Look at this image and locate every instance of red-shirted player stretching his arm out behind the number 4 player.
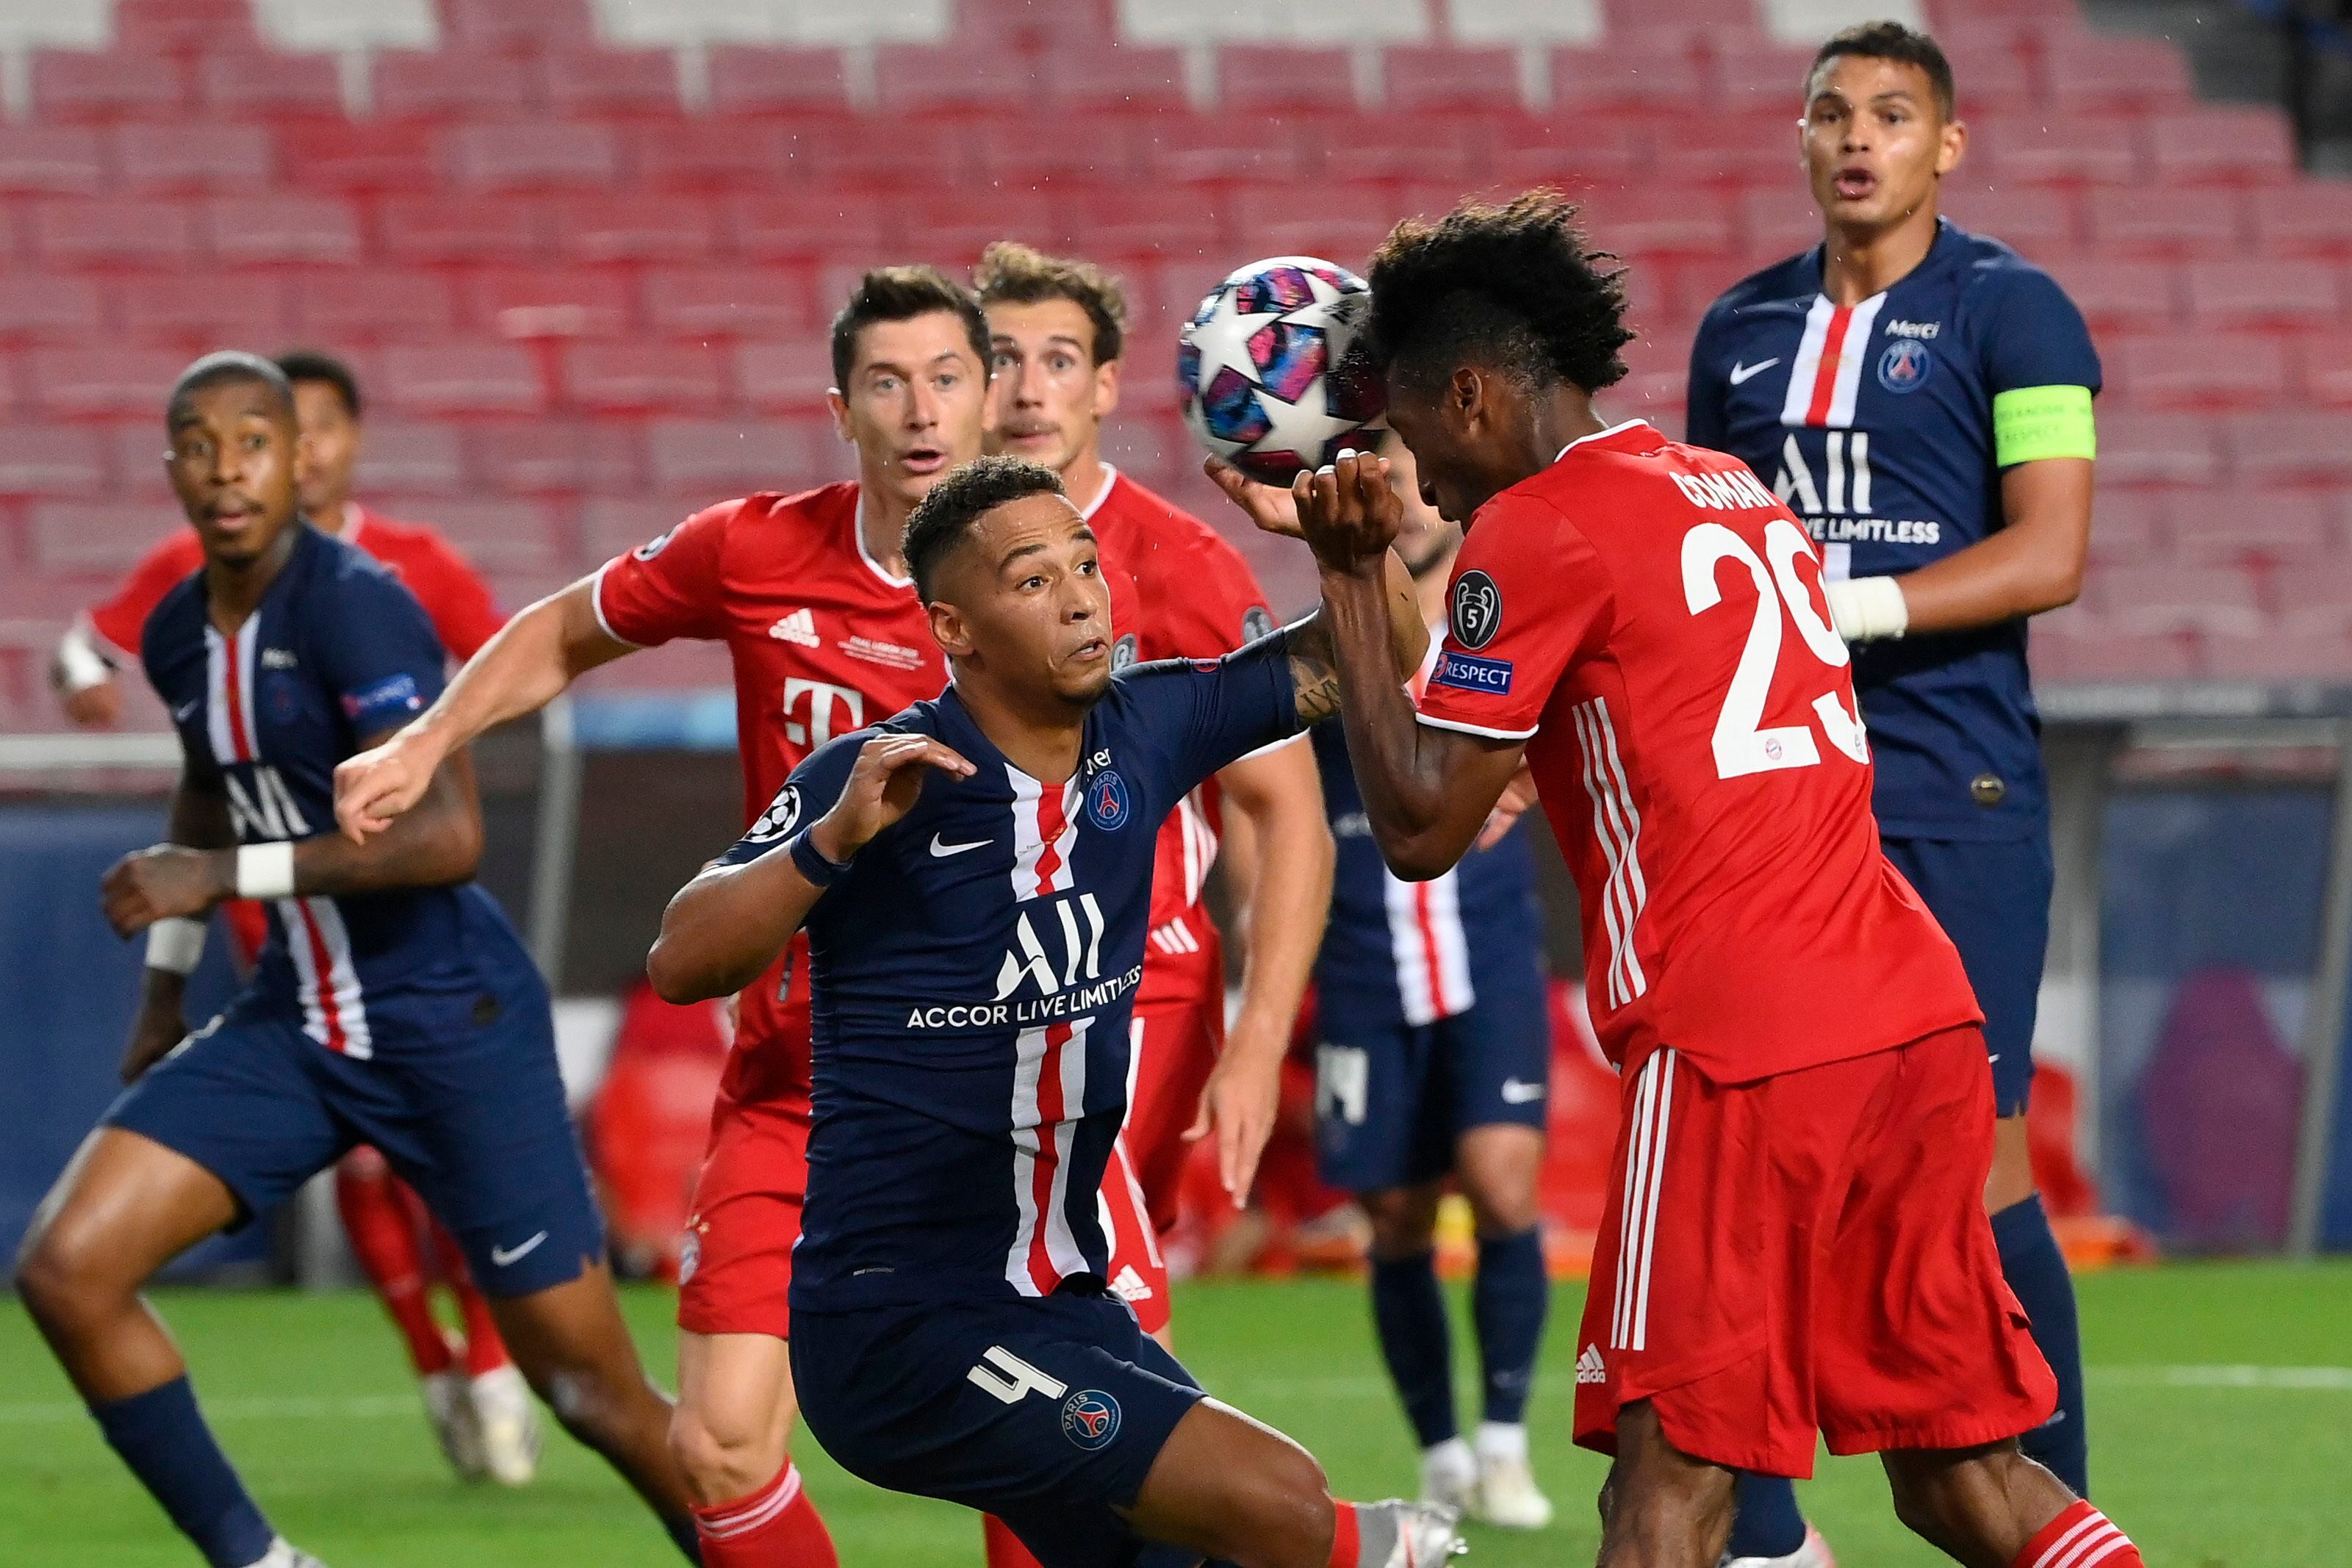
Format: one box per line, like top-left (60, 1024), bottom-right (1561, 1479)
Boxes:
top-left (337, 268), bottom-right (1195, 1568)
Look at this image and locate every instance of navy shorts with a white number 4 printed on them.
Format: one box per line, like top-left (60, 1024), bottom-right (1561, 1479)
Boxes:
top-left (793, 1290), bottom-right (1202, 1568)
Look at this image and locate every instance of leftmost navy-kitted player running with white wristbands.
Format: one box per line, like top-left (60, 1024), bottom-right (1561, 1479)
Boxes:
top-left (16, 353), bottom-right (694, 1568)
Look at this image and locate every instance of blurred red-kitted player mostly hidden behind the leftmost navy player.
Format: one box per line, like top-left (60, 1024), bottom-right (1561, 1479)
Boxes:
top-left (51, 350), bottom-right (539, 1486)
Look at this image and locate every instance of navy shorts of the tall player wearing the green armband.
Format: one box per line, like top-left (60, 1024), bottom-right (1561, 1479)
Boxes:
top-left (1884, 830), bottom-right (2053, 1117)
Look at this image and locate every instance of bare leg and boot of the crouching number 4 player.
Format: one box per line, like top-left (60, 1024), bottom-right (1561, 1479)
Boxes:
top-left (1126, 1399), bottom-right (1456, 1568)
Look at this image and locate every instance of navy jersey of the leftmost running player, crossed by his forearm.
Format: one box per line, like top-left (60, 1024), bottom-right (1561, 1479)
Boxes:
top-left (141, 524), bottom-right (529, 1056)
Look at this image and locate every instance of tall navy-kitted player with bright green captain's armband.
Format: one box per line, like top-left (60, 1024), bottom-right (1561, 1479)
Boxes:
top-left (1689, 21), bottom-right (2100, 1542)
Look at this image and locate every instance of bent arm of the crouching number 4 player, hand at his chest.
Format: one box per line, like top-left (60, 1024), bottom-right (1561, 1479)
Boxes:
top-left (644, 733), bottom-right (971, 1001)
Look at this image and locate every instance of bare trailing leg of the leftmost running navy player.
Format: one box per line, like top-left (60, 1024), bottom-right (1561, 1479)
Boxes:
top-left (477, 1262), bottom-right (694, 1558)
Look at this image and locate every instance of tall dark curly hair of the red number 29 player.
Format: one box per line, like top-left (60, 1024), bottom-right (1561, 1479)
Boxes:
top-left (1367, 190), bottom-right (1635, 392)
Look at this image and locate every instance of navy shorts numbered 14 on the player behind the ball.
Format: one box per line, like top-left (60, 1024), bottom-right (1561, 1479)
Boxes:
top-left (1315, 982), bottom-right (1553, 1192)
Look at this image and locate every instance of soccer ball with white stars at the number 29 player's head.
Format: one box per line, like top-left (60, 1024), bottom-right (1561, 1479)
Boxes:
top-left (1176, 256), bottom-right (1383, 484)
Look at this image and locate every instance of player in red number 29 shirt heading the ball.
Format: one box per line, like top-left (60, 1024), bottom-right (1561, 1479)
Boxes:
top-left (1220, 193), bottom-right (2140, 1568)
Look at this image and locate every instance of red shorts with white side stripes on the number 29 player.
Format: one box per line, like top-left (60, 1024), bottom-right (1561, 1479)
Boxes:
top-left (1576, 1025), bottom-right (2058, 1476)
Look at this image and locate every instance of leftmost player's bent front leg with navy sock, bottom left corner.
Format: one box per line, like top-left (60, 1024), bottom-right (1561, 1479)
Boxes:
top-left (16, 1129), bottom-right (311, 1568)
